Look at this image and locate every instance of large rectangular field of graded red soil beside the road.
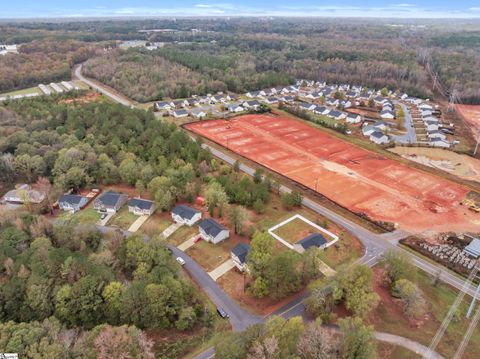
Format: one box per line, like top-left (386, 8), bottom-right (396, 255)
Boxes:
top-left (186, 115), bottom-right (480, 233)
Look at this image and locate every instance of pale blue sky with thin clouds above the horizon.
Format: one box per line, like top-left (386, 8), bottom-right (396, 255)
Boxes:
top-left (0, 0), bottom-right (480, 18)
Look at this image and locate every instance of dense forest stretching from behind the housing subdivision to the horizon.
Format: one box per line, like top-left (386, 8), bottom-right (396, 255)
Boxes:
top-left (0, 18), bottom-right (480, 103)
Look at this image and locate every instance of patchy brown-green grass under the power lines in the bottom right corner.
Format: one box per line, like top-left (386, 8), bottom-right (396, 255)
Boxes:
top-left (369, 268), bottom-right (480, 359)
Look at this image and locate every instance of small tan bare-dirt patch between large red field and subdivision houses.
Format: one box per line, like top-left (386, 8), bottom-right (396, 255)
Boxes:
top-left (389, 147), bottom-right (480, 183)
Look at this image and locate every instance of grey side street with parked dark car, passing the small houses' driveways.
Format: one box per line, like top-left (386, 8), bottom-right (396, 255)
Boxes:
top-left (168, 245), bottom-right (262, 331)
